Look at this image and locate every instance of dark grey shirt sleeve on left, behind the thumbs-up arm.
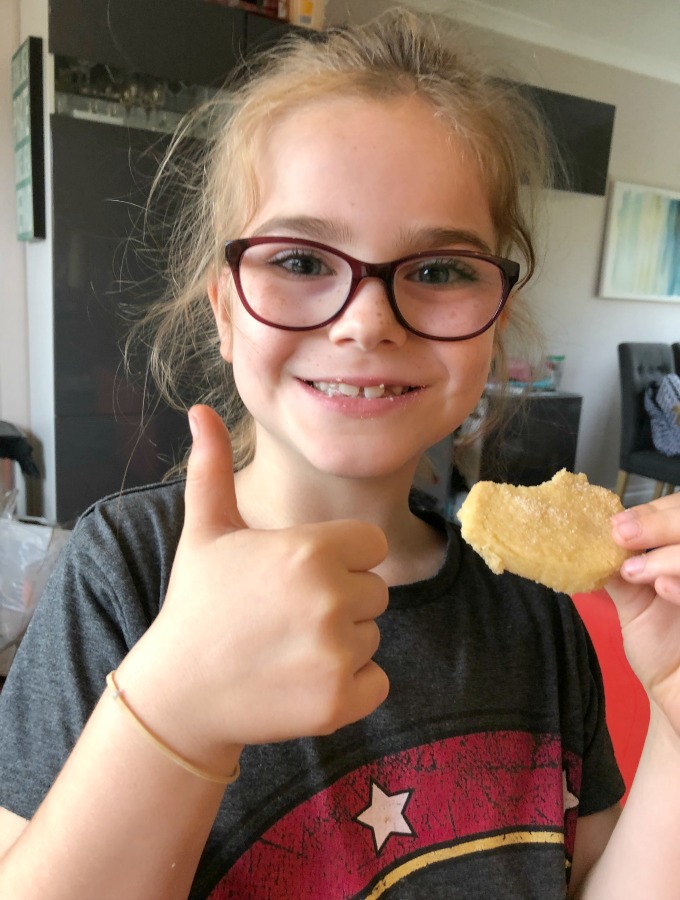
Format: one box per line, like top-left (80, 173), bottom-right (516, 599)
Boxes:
top-left (0, 502), bottom-right (155, 819)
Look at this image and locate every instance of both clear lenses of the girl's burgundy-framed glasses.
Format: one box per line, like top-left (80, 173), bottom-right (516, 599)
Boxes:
top-left (239, 241), bottom-right (503, 338)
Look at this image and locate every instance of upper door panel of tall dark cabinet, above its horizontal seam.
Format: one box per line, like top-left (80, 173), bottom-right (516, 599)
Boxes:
top-left (50, 115), bottom-right (165, 416)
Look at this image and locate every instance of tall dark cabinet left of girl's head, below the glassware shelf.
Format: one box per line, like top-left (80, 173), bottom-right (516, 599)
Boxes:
top-left (51, 115), bottom-right (188, 522)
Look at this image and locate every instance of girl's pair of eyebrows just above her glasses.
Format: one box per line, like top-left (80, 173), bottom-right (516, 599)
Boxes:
top-left (251, 216), bottom-right (495, 255)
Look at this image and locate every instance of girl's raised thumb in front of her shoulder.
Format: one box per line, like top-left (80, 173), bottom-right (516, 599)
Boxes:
top-left (184, 405), bottom-right (247, 534)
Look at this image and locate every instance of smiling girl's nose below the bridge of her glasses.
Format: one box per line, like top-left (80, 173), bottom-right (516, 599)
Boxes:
top-left (329, 276), bottom-right (407, 350)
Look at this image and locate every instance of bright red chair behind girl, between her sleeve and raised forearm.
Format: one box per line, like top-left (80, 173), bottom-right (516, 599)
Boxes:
top-left (573, 590), bottom-right (649, 802)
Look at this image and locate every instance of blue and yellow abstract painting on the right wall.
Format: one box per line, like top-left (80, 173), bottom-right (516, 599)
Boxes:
top-left (600, 181), bottom-right (680, 303)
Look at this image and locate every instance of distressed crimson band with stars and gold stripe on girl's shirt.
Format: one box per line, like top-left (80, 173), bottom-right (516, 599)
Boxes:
top-left (210, 731), bottom-right (581, 900)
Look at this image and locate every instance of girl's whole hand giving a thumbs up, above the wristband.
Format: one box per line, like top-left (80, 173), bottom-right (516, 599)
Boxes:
top-left (127, 406), bottom-right (388, 765)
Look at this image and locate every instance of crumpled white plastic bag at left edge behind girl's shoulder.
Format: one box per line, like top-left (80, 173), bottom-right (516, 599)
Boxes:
top-left (0, 517), bottom-right (70, 675)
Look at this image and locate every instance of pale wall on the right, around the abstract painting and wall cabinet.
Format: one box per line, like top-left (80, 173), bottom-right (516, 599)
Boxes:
top-left (328, 0), bottom-right (680, 501)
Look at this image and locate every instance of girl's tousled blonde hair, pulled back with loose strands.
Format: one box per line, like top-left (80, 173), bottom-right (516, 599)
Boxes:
top-left (130, 9), bottom-right (553, 467)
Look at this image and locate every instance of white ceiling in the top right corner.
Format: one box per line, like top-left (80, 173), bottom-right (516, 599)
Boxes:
top-left (448, 0), bottom-right (680, 84)
